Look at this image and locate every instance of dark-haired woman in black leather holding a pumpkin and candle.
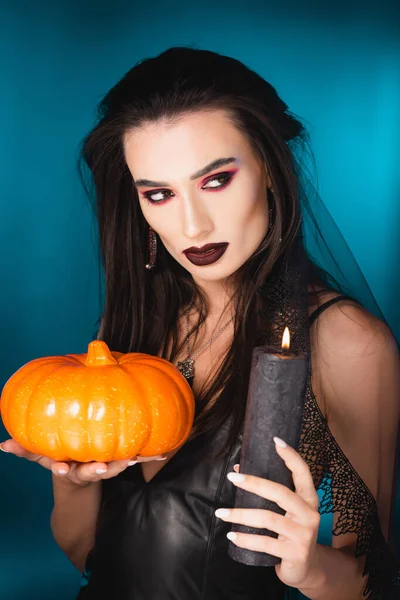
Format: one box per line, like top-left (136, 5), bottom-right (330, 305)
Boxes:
top-left (4, 48), bottom-right (400, 600)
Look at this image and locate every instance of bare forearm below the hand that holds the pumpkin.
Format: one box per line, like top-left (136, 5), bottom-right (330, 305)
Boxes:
top-left (50, 474), bottom-right (102, 572)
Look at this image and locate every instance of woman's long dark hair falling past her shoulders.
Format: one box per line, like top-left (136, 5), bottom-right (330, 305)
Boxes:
top-left (80, 47), bottom-right (329, 454)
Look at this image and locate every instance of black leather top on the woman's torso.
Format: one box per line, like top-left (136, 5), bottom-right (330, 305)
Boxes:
top-left (79, 420), bottom-right (285, 600)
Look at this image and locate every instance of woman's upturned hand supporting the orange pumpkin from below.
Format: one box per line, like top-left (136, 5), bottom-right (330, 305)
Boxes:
top-left (0, 438), bottom-right (167, 486)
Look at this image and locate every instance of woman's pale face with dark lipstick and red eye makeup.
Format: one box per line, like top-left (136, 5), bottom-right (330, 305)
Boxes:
top-left (124, 110), bottom-right (269, 285)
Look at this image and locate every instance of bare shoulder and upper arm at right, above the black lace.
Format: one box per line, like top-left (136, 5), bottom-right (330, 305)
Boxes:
top-left (311, 294), bottom-right (400, 528)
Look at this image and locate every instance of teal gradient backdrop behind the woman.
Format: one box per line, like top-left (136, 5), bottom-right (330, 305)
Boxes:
top-left (0, 0), bottom-right (400, 600)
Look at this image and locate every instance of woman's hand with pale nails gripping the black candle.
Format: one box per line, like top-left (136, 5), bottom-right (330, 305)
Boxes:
top-left (215, 438), bottom-right (320, 588)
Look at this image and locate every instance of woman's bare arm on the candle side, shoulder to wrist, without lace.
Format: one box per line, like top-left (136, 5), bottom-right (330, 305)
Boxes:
top-left (301, 302), bottom-right (400, 600)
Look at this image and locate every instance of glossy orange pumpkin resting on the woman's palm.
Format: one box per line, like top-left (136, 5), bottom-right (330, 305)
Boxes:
top-left (0, 340), bottom-right (194, 462)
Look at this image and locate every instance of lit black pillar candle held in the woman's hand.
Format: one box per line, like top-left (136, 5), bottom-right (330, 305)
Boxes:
top-left (229, 328), bottom-right (308, 567)
